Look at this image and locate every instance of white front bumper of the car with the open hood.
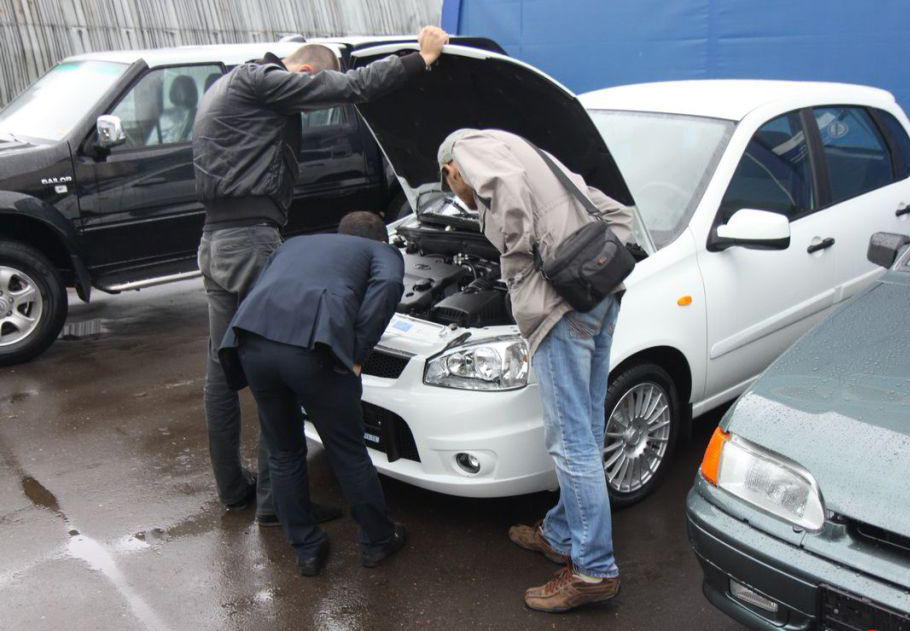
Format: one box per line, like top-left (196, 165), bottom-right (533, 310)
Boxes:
top-left (305, 366), bottom-right (558, 497)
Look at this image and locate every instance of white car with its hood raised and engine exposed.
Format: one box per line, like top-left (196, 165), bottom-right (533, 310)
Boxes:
top-left (306, 44), bottom-right (910, 504)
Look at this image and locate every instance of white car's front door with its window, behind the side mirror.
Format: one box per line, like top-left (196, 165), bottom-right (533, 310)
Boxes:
top-left (698, 111), bottom-right (837, 407)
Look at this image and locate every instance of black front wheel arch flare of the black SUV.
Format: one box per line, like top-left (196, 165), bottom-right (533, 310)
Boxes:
top-left (0, 191), bottom-right (92, 302)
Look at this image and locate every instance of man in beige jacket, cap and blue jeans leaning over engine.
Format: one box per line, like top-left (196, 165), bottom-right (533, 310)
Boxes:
top-left (438, 129), bottom-right (632, 612)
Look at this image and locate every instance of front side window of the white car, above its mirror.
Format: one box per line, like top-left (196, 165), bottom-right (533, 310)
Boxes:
top-left (719, 112), bottom-right (816, 223)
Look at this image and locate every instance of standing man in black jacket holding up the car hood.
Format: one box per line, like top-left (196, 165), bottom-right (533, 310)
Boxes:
top-left (193, 27), bottom-right (448, 525)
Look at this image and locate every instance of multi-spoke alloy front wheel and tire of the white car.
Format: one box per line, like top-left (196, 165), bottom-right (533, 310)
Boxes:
top-left (603, 363), bottom-right (682, 507)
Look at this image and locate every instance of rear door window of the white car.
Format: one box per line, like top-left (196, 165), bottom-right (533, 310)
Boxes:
top-left (813, 106), bottom-right (894, 204)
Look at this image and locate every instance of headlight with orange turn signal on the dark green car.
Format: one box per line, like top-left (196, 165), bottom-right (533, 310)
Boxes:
top-left (701, 428), bottom-right (825, 531)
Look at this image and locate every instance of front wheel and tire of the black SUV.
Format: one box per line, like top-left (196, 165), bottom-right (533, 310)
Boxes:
top-left (0, 240), bottom-right (68, 366)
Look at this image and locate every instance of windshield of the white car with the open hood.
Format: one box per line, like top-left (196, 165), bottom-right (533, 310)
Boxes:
top-left (588, 110), bottom-right (734, 248)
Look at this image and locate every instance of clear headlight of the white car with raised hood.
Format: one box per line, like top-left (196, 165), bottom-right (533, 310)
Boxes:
top-left (423, 337), bottom-right (529, 390)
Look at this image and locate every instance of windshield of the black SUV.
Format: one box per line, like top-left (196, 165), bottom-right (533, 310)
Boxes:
top-left (0, 61), bottom-right (128, 141)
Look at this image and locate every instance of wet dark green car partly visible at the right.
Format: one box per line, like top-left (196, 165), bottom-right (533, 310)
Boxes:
top-left (687, 233), bottom-right (910, 631)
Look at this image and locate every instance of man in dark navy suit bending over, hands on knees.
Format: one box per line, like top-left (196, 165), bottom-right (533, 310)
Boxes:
top-left (220, 212), bottom-right (407, 576)
